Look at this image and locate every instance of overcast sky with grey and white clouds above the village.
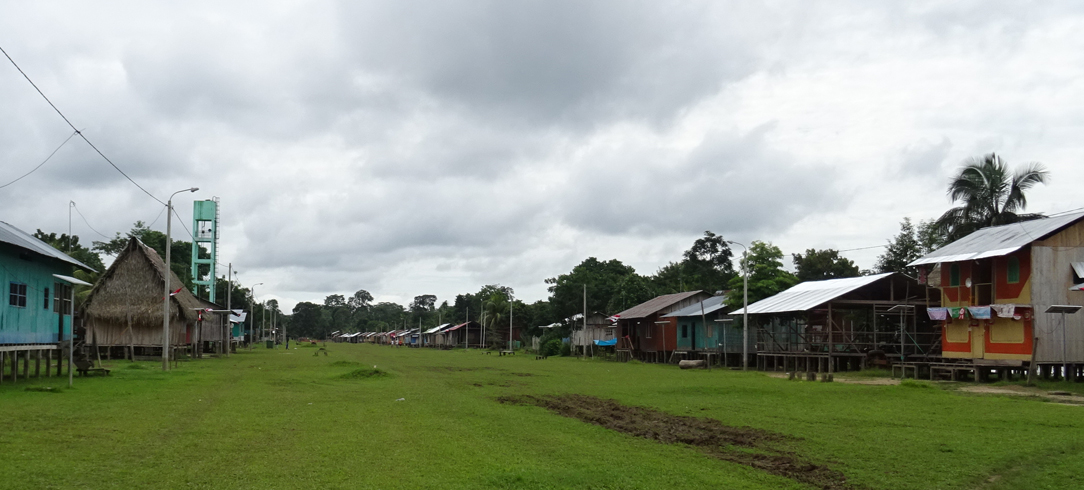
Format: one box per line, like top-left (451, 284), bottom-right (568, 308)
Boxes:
top-left (0, 0), bottom-right (1084, 308)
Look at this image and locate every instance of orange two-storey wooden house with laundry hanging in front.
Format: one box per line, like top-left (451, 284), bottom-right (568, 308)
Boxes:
top-left (911, 212), bottom-right (1084, 375)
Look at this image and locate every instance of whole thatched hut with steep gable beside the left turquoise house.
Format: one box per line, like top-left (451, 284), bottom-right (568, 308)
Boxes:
top-left (82, 237), bottom-right (204, 347)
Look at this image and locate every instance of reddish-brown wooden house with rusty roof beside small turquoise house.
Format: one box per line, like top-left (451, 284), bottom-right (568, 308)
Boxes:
top-left (615, 291), bottom-right (711, 362)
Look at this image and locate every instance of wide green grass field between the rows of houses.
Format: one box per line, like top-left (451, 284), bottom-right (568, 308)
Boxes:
top-left (0, 345), bottom-right (1084, 489)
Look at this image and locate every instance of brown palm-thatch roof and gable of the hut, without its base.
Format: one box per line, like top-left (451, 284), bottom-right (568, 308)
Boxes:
top-left (83, 237), bottom-right (203, 324)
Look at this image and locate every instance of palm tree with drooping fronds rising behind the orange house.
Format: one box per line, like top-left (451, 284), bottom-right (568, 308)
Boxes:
top-left (934, 153), bottom-right (1049, 242)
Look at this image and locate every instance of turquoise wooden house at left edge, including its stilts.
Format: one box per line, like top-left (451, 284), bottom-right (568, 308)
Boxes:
top-left (0, 221), bottom-right (93, 383)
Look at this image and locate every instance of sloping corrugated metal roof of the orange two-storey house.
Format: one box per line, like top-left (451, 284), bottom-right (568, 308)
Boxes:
top-left (908, 212), bottom-right (1084, 266)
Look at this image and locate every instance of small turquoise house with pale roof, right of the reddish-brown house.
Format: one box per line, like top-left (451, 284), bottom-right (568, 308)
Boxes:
top-left (662, 296), bottom-right (756, 365)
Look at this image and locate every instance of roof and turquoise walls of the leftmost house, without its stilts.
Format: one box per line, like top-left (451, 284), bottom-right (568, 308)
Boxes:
top-left (0, 221), bottom-right (93, 348)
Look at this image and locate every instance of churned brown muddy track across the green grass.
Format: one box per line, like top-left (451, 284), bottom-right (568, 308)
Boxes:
top-left (498, 395), bottom-right (859, 490)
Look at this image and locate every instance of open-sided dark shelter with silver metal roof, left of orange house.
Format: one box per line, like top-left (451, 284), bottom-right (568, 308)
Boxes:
top-left (731, 272), bottom-right (941, 373)
